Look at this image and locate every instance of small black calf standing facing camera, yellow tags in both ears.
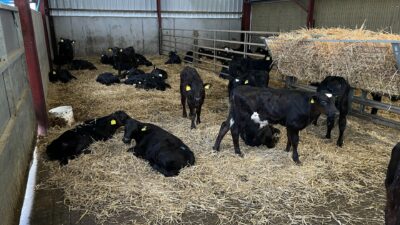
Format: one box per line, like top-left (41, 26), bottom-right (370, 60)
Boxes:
top-left (180, 66), bottom-right (211, 129)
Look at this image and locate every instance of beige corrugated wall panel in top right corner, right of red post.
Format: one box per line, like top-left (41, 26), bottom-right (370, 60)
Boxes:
top-left (314, 0), bottom-right (400, 33)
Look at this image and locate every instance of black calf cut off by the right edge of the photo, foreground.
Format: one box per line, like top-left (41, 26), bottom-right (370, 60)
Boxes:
top-left (385, 142), bottom-right (400, 225)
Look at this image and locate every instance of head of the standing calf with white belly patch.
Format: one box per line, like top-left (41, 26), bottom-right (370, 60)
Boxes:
top-left (310, 92), bottom-right (338, 118)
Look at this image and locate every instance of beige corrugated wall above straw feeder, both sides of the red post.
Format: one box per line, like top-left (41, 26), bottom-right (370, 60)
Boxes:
top-left (251, 0), bottom-right (400, 33)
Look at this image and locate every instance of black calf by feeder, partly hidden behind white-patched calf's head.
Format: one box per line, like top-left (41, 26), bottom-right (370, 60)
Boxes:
top-left (314, 76), bottom-right (350, 147)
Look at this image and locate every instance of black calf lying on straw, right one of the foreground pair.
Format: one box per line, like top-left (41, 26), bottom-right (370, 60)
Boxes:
top-left (123, 119), bottom-right (195, 177)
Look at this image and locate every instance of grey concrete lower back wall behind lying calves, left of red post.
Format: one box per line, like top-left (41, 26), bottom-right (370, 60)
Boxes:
top-left (54, 16), bottom-right (158, 57)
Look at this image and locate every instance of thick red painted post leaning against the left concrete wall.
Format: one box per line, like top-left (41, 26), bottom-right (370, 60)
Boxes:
top-left (15, 0), bottom-right (48, 136)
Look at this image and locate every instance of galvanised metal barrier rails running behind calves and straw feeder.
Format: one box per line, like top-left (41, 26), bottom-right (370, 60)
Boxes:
top-left (160, 28), bottom-right (400, 129)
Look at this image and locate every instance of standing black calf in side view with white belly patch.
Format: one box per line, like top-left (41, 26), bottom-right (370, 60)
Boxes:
top-left (213, 86), bottom-right (337, 163)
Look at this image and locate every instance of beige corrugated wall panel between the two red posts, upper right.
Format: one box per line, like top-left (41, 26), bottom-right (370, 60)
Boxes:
top-left (251, 1), bottom-right (307, 32)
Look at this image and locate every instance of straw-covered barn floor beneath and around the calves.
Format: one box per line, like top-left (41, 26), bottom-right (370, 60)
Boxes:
top-left (31, 56), bottom-right (400, 224)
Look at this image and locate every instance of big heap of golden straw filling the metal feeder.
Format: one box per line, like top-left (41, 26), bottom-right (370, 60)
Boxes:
top-left (269, 28), bottom-right (400, 95)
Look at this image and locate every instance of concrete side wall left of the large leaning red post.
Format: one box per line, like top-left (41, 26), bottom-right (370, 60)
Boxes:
top-left (0, 5), bottom-right (36, 225)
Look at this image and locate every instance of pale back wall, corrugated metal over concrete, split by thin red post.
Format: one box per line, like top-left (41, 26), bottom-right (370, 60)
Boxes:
top-left (50, 0), bottom-right (243, 56)
